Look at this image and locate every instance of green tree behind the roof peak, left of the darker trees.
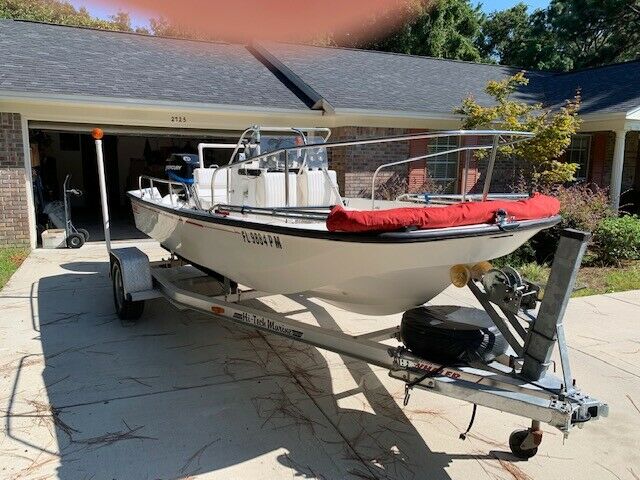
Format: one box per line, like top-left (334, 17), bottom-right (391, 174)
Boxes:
top-left (352, 0), bottom-right (482, 61)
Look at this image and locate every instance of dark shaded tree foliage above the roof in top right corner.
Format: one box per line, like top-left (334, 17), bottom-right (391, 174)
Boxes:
top-left (479, 0), bottom-right (640, 71)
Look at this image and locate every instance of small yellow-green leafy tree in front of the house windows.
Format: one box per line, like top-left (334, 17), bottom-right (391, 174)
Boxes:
top-left (455, 72), bottom-right (580, 187)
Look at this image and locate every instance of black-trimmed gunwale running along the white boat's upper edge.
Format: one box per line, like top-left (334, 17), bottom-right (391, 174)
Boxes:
top-left (127, 192), bottom-right (561, 244)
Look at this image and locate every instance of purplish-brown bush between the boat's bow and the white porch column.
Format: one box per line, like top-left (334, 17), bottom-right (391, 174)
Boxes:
top-left (531, 184), bottom-right (615, 263)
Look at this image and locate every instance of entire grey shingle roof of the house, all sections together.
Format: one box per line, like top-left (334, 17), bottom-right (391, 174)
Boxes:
top-left (0, 20), bottom-right (640, 114)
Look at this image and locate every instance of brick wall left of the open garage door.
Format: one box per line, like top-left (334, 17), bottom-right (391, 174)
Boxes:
top-left (0, 112), bottom-right (29, 246)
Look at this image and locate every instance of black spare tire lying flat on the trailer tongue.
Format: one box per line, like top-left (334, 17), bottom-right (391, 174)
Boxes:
top-left (400, 306), bottom-right (509, 364)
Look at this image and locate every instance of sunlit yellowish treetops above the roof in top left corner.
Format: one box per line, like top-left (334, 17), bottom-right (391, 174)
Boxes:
top-left (0, 0), bottom-right (138, 32)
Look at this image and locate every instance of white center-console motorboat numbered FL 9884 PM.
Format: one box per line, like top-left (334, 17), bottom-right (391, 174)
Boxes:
top-left (128, 127), bottom-right (559, 315)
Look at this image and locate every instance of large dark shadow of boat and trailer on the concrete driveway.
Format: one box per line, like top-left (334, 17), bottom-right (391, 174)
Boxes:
top-left (6, 262), bottom-right (510, 480)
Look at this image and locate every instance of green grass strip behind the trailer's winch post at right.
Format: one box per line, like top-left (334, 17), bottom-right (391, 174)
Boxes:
top-left (517, 261), bottom-right (640, 297)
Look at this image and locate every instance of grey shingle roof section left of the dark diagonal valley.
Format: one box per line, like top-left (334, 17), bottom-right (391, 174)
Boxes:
top-left (0, 20), bottom-right (308, 110)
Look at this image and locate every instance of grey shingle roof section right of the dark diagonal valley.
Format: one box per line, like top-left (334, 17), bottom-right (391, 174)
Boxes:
top-left (265, 44), bottom-right (544, 114)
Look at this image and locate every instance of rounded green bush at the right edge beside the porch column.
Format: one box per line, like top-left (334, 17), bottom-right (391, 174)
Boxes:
top-left (591, 215), bottom-right (640, 266)
